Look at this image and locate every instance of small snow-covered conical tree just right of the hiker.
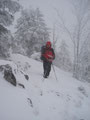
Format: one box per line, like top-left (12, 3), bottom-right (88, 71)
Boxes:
top-left (55, 40), bottom-right (72, 71)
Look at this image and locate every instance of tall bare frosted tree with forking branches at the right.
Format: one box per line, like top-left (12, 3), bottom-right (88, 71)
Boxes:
top-left (56, 0), bottom-right (90, 79)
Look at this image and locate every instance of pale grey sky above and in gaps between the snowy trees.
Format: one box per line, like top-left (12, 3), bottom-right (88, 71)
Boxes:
top-left (11, 0), bottom-right (74, 59)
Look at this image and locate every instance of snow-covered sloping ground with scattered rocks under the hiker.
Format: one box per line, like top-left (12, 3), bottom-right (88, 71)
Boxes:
top-left (0, 54), bottom-right (90, 120)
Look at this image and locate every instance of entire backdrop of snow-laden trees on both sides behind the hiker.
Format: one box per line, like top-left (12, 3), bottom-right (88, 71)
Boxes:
top-left (0, 0), bottom-right (90, 82)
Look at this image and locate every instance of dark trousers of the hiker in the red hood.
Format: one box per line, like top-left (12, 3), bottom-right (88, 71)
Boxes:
top-left (43, 61), bottom-right (52, 77)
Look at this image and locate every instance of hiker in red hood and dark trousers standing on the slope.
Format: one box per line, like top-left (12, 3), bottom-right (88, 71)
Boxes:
top-left (41, 41), bottom-right (55, 78)
